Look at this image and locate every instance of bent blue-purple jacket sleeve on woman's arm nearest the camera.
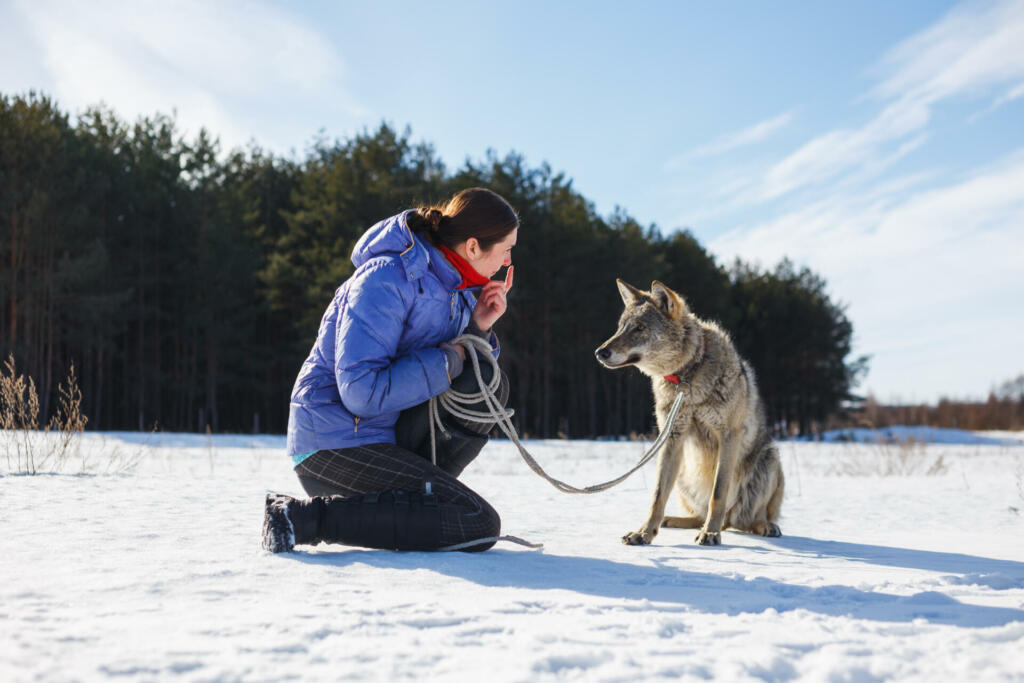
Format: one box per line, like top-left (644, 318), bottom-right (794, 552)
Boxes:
top-left (335, 263), bottom-right (452, 418)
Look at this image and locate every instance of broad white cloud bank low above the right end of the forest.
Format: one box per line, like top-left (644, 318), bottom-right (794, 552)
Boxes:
top-left (710, 145), bottom-right (1024, 399)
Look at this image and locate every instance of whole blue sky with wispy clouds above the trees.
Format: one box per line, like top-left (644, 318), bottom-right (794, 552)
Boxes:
top-left (0, 0), bottom-right (1024, 401)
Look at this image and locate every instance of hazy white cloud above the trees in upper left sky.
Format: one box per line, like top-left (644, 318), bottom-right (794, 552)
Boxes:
top-left (7, 0), bottom-right (365, 152)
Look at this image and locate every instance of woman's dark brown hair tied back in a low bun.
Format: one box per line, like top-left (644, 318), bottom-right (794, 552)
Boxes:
top-left (406, 187), bottom-right (519, 251)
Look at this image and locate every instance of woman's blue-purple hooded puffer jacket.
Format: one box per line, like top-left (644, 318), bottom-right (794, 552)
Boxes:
top-left (288, 212), bottom-right (498, 465)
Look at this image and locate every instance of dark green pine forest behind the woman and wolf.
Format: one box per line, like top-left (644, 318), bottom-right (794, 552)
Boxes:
top-left (0, 93), bottom-right (866, 437)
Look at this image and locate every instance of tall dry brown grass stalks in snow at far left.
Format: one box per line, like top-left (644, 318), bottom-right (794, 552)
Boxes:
top-left (0, 355), bottom-right (113, 474)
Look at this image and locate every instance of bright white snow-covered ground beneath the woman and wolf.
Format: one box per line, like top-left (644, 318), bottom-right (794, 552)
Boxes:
top-left (0, 434), bottom-right (1024, 683)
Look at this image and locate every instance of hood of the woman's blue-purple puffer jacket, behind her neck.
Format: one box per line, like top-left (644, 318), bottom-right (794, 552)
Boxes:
top-left (352, 211), bottom-right (462, 289)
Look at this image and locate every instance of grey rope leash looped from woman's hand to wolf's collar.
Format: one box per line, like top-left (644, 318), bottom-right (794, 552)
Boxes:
top-left (430, 334), bottom-right (690, 550)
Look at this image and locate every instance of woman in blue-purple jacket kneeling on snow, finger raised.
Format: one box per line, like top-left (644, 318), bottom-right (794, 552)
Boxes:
top-left (263, 187), bottom-right (519, 552)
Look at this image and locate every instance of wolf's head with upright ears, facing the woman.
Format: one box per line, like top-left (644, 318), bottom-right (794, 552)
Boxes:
top-left (595, 280), bottom-right (700, 377)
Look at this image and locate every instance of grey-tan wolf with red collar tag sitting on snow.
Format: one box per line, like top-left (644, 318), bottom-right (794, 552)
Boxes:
top-left (596, 280), bottom-right (784, 546)
